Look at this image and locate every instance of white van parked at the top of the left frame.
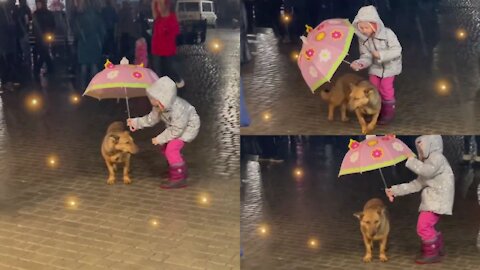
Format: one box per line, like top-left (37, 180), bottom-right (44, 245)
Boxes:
top-left (175, 0), bottom-right (217, 27)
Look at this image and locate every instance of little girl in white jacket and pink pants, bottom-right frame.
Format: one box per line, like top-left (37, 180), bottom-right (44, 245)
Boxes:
top-left (385, 135), bottom-right (455, 264)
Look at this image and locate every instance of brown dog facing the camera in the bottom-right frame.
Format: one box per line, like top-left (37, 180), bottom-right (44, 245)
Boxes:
top-left (353, 198), bottom-right (390, 262)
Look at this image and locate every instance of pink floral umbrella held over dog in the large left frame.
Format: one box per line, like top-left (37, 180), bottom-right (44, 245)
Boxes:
top-left (83, 57), bottom-right (158, 118)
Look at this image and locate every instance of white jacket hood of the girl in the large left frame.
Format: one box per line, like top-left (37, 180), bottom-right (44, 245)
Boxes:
top-left (147, 76), bottom-right (177, 110)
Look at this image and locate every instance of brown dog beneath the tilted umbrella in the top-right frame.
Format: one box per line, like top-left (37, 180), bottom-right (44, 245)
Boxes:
top-left (320, 73), bottom-right (382, 134)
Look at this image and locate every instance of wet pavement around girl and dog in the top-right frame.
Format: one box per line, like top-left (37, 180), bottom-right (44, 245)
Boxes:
top-left (241, 0), bottom-right (480, 135)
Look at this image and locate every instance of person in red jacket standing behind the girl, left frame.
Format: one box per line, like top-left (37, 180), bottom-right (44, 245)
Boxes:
top-left (152, 0), bottom-right (185, 88)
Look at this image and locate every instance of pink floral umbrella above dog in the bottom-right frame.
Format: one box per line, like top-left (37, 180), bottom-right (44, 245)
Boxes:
top-left (338, 135), bottom-right (415, 188)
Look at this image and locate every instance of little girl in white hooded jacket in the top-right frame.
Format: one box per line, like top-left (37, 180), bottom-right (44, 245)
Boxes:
top-left (351, 6), bottom-right (402, 125)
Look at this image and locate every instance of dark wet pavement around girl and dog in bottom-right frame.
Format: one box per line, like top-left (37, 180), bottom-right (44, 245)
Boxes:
top-left (241, 136), bottom-right (480, 270)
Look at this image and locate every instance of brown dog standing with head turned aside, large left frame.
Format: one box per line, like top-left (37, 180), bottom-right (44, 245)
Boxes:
top-left (102, 122), bottom-right (138, 185)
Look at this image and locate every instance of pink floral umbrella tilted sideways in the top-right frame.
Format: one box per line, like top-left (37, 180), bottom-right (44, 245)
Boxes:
top-left (297, 19), bottom-right (355, 92)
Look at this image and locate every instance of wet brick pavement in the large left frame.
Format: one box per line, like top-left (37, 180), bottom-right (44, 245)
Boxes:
top-left (0, 29), bottom-right (240, 270)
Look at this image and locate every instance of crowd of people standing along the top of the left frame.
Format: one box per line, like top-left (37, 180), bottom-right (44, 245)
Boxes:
top-left (0, 0), bottom-right (184, 91)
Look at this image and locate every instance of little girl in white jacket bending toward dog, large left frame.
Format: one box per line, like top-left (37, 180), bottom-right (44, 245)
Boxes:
top-left (127, 76), bottom-right (200, 189)
